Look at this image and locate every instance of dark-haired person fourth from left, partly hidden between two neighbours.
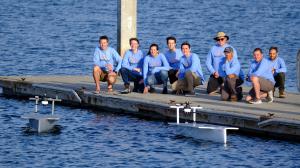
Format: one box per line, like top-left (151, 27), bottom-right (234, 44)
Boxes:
top-left (165, 36), bottom-right (183, 90)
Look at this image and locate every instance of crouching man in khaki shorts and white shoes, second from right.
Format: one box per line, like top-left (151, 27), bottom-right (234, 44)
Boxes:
top-left (246, 48), bottom-right (275, 104)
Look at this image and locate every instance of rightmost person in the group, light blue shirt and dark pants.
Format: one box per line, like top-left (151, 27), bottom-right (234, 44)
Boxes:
top-left (269, 47), bottom-right (286, 98)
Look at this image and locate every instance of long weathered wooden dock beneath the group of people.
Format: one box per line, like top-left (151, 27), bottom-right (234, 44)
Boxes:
top-left (0, 76), bottom-right (300, 140)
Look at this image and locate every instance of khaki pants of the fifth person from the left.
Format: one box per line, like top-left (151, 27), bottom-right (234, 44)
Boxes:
top-left (172, 71), bottom-right (201, 92)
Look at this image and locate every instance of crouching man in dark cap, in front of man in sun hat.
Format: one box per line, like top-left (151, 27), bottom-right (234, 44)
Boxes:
top-left (220, 47), bottom-right (244, 101)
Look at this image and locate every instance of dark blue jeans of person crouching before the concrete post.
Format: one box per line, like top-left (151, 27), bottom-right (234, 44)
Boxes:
top-left (120, 68), bottom-right (144, 92)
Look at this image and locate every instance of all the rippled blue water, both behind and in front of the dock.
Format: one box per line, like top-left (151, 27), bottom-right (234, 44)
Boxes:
top-left (0, 0), bottom-right (300, 167)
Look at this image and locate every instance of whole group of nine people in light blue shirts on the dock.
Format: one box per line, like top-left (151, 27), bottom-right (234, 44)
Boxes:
top-left (93, 32), bottom-right (286, 104)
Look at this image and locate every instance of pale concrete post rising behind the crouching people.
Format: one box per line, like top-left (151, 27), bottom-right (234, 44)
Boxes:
top-left (118, 0), bottom-right (137, 57)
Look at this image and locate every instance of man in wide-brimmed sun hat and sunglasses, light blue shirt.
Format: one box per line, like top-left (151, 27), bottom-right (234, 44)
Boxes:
top-left (206, 32), bottom-right (237, 94)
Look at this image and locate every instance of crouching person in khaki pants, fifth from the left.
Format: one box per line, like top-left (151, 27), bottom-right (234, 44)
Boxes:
top-left (176, 42), bottom-right (204, 95)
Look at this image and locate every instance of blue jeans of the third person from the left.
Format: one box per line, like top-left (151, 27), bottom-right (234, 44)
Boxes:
top-left (147, 70), bottom-right (168, 88)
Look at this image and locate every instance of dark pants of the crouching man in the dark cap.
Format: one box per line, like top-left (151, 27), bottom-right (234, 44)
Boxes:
top-left (221, 77), bottom-right (244, 100)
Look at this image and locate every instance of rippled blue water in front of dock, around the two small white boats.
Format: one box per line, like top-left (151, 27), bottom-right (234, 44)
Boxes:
top-left (0, 97), bottom-right (300, 167)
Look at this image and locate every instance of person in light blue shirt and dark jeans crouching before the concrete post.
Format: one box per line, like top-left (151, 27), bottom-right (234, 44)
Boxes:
top-left (120, 38), bottom-right (144, 93)
